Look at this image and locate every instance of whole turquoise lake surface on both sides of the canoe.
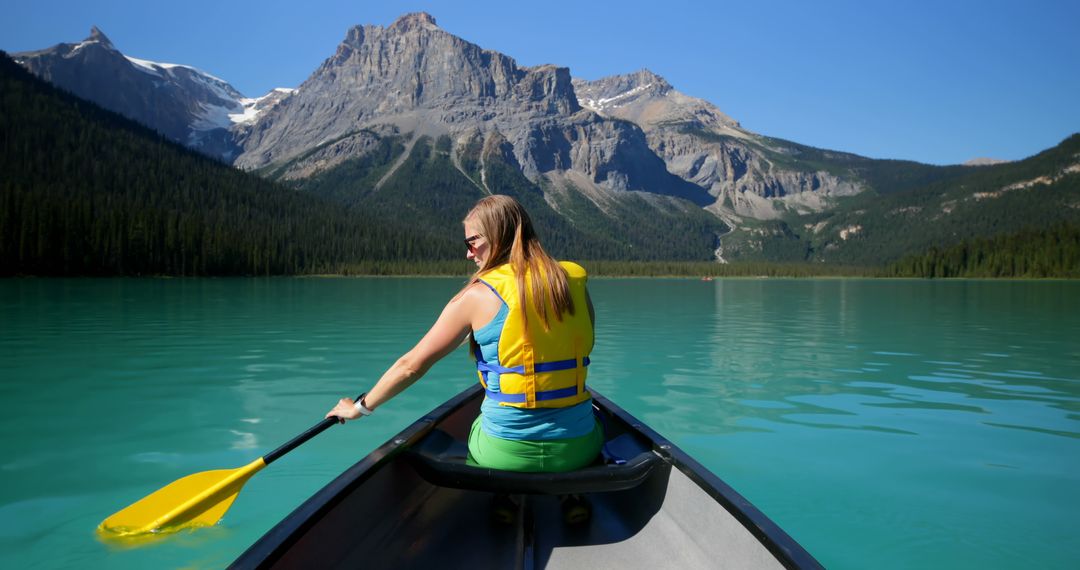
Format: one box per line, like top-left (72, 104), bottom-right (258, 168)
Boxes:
top-left (0, 279), bottom-right (1080, 569)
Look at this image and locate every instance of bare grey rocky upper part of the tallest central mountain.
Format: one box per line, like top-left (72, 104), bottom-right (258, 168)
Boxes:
top-left (237, 13), bottom-right (713, 205)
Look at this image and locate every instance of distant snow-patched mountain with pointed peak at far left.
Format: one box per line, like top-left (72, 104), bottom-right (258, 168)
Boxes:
top-left (13, 27), bottom-right (291, 162)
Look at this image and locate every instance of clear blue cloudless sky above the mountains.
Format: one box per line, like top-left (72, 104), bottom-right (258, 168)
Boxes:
top-left (0, 0), bottom-right (1080, 164)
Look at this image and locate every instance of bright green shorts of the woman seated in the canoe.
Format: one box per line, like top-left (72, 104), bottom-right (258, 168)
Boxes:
top-left (469, 417), bottom-right (604, 473)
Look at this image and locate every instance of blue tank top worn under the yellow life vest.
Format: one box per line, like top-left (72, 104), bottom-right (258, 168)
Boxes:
top-left (473, 303), bottom-right (596, 442)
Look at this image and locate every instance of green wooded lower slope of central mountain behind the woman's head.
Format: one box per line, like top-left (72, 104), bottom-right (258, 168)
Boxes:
top-left (274, 132), bottom-right (727, 261)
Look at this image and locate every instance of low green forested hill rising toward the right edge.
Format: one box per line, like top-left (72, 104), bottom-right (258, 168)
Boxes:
top-left (720, 134), bottom-right (1080, 264)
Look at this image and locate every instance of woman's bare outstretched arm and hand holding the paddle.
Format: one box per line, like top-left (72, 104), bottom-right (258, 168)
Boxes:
top-left (326, 288), bottom-right (477, 421)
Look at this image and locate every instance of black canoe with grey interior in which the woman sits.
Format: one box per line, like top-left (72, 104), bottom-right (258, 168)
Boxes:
top-left (230, 385), bottom-right (821, 569)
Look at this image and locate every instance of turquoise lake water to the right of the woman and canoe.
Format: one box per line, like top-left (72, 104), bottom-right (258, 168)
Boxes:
top-left (590, 280), bottom-right (1080, 568)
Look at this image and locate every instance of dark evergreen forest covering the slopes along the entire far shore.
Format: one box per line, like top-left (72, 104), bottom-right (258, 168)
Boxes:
top-left (0, 54), bottom-right (1080, 277)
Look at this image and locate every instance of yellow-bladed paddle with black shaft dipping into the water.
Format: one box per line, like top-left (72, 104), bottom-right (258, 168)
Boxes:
top-left (97, 396), bottom-right (360, 539)
